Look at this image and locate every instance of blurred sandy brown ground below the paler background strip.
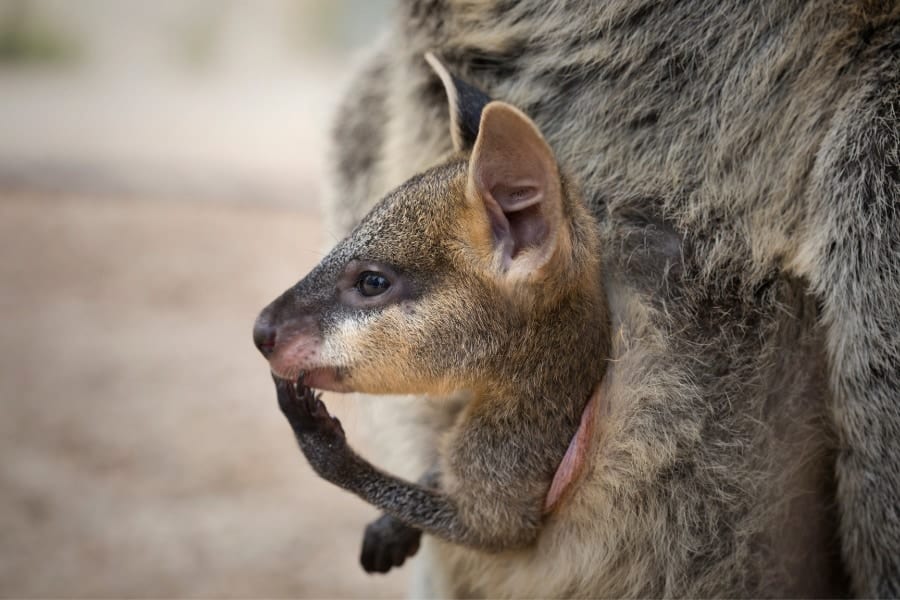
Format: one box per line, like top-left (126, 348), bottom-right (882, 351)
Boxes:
top-left (0, 192), bottom-right (409, 598)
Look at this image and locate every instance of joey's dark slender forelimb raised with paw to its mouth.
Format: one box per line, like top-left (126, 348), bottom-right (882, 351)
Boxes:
top-left (274, 375), bottom-right (521, 550)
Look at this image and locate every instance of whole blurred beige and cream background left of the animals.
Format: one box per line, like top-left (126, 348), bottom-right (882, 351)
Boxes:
top-left (0, 0), bottom-right (409, 597)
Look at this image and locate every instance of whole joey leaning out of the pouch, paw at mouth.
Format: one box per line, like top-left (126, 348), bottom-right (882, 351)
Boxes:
top-left (254, 57), bottom-right (609, 570)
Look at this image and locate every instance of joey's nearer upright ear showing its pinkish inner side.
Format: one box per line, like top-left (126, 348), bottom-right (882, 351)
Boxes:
top-left (466, 102), bottom-right (570, 278)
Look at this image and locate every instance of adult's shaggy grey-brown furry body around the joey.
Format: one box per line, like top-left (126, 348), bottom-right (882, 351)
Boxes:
top-left (320, 0), bottom-right (900, 597)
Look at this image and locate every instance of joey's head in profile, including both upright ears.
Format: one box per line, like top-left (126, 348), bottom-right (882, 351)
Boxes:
top-left (254, 57), bottom-right (599, 393)
